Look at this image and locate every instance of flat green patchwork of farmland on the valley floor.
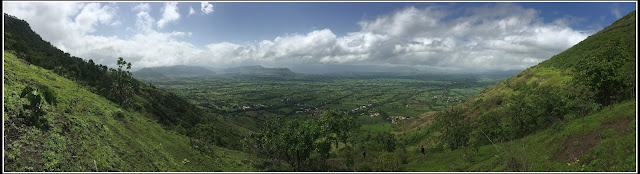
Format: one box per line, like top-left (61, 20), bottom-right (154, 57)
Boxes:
top-left (139, 74), bottom-right (502, 132)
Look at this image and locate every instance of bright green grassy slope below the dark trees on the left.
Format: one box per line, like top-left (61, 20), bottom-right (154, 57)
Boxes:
top-left (4, 52), bottom-right (254, 171)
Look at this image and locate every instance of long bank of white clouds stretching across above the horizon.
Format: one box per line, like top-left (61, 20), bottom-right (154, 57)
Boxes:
top-left (3, 2), bottom-right (589, 70)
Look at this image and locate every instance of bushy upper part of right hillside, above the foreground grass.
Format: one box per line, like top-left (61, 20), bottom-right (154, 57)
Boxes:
top-left (461, 11), bottom-right (636, 140)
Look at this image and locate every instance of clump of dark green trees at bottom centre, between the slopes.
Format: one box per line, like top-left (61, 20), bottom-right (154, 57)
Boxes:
top-left (253, 112), bottom-right (362, 170)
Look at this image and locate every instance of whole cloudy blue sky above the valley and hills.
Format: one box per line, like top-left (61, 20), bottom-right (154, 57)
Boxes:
top-left (3, 1), bottom-right (637, 71)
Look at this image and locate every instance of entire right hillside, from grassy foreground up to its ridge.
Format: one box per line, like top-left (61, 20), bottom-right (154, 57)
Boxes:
top-left (403, 11), bottom-right (637, 171)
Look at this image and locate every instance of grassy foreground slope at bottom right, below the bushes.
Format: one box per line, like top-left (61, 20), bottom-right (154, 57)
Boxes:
top-left (402, 101), bottom-right (637, 172)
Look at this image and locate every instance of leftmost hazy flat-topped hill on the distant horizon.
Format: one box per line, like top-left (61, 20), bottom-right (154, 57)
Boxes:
top-left (133, 65), bottom-right (216, 79)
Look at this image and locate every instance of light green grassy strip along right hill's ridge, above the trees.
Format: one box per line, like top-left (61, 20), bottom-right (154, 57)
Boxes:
top-left (465, 11), bottom-right (636, 117)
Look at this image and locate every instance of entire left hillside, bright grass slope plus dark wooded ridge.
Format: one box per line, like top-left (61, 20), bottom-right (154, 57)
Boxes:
top-left (4, 14), bottom-right (250, 171)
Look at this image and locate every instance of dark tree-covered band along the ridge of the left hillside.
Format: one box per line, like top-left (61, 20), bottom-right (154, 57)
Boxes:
top-left (4, 14), bottom-right (255, 150)
